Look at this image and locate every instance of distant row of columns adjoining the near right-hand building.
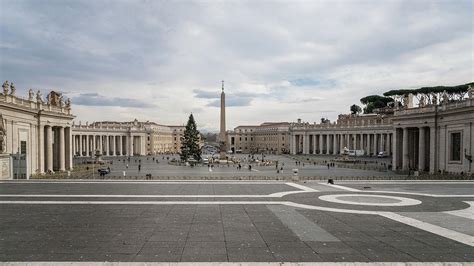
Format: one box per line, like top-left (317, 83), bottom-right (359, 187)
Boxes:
top-left (290, 132), bottom-right (392, 155)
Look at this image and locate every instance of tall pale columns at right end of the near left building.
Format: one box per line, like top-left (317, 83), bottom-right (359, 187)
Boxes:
top-left (38, 125), bottom-right (72, 173)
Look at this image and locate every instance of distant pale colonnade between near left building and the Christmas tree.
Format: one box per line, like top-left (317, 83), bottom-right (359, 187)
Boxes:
top-left (73, 133), bottom-right (146, 156)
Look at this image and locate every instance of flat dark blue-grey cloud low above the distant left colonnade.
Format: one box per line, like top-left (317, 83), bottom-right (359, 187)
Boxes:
top-left (72, 93), bottom-right (154, 108)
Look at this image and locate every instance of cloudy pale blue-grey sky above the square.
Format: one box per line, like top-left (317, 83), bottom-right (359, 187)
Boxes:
top-left (0, 0), bottom-right (474, 131)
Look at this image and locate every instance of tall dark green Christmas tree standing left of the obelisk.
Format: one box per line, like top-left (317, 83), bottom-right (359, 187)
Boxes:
top-left (180, 114), bottom-right (201, 161)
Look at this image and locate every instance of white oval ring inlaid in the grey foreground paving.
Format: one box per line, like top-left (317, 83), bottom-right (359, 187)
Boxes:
top-left (319, 194), bottom-right (421, 206)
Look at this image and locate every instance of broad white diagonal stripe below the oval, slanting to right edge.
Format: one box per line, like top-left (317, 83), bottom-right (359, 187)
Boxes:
top-left (379, 212), bottom-right (474, 247)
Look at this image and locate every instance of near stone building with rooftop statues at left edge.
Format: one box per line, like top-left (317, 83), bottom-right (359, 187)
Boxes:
top-left (0, 82), bottom-right (74, 179)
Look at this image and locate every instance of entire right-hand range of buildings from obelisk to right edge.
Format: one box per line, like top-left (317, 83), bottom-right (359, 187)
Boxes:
top-left (227, 87), bottom-right (474, 174)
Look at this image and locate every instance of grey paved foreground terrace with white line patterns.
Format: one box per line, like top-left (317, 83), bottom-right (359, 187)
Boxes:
top-left (0, 180), bottom-right (474, 264)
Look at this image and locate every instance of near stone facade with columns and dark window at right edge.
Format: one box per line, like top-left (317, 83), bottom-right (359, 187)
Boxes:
top-left (393, 94), bottom-right (474, 173)
